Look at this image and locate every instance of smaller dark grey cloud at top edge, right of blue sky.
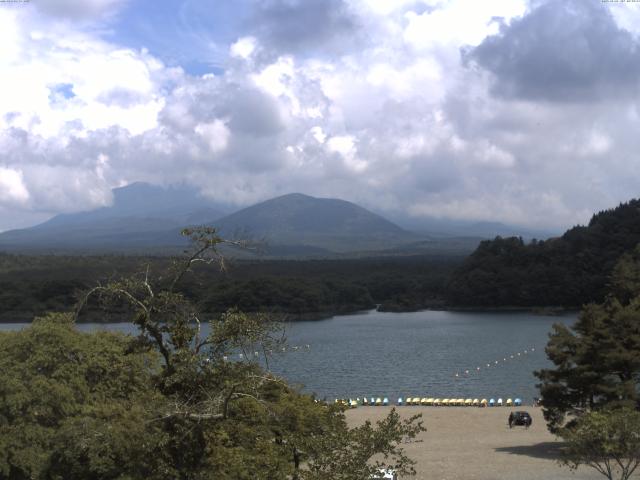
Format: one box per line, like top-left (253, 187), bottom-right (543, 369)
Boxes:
top-left (251, 0), bottom-right (358, 53)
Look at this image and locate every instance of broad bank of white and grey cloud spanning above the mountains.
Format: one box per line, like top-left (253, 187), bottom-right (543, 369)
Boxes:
top-left (0, 0), bottom-right (640, 234)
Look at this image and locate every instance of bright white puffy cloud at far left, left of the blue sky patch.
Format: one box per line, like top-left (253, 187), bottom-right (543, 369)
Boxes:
top-left (0, 11), bottom-right (172, 138)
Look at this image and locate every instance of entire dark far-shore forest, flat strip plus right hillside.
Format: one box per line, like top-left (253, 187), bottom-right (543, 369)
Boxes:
top-left (0, 195), bottom-right (640, 322)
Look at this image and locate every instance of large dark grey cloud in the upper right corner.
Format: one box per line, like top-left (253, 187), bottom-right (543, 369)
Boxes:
top-left (463, 0), bottom-right (640, 102)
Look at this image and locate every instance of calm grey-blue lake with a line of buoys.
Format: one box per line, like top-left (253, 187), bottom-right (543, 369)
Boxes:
top-left (0, 311), bottom-right (576, 403)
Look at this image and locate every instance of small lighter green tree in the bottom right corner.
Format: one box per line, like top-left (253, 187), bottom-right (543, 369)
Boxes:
top-left (561, 408), bottom-right (640, 480)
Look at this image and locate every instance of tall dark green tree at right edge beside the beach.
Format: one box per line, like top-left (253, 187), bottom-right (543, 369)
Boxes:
top-left (536, 250), bottom-right (640, 432)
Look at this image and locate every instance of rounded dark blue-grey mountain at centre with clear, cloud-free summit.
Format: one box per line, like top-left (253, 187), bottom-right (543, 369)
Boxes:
top-left (215, 193), bottom-right (421, 253)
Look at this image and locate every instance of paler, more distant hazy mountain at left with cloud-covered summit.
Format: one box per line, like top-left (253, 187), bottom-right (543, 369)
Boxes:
top-left (0, 183), bottom-right (228, 252)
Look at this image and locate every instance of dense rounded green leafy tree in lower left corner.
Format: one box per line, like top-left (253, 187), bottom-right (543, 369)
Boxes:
top-left (0, 314), bottom-right (158, 479)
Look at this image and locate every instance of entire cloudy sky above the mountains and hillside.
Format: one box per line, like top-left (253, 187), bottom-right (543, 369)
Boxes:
top-left (0, 0), bottom-right (640, 231)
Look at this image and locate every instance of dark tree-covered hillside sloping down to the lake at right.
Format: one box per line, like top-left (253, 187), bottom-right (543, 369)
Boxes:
top-left (446, 200), bottom-right (640, 307)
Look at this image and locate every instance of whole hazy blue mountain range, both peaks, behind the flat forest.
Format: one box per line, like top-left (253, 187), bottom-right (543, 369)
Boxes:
top-left (0, 183), bottom-right (479, 258)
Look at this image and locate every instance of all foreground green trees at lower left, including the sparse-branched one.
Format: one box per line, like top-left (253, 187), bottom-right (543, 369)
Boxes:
top-left (0, 230), bottom-right (424, 480)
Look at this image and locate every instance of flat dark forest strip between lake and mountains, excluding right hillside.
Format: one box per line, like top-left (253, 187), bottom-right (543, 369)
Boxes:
top-left (0, 251), bottom-right (461, 321)
